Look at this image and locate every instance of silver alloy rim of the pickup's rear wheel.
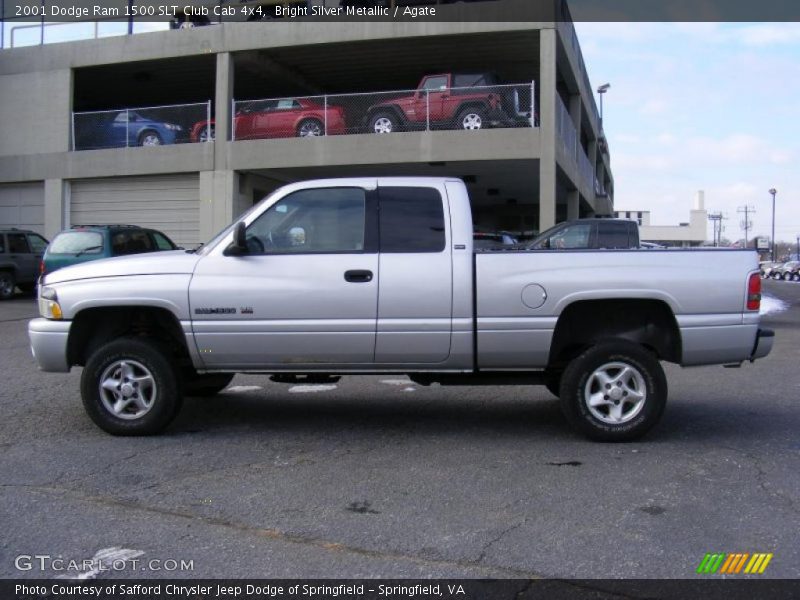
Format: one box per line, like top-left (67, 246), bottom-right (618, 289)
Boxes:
top-left (583, 362), bottom-right (647, 425)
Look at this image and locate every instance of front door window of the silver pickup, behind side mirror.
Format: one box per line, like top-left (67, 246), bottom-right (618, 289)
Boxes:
top-left (247, 188), bottom-right (367, 254)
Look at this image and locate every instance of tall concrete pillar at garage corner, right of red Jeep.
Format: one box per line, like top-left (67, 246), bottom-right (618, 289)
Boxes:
top-left (538, 29), bottom-right (557, 231)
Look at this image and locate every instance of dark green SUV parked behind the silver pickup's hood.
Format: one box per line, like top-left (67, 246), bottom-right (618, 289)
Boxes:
top-left (40, 225), bottom-right (179, 275)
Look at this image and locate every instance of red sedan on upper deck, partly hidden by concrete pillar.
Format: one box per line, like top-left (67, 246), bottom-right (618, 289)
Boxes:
top-left (190, 98), bottom-right (346, 142)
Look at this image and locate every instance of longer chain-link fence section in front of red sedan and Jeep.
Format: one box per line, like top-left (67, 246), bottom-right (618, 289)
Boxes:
top-left (223, 82), bottom-right (538, 140)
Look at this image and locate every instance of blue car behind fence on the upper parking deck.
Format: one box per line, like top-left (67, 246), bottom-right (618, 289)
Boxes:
top-left (75, 110), bottom-right (188, 150)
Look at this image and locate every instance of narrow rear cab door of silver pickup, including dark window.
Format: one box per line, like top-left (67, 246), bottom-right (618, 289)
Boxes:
top-left (375, 180), bottom-right (453, 365)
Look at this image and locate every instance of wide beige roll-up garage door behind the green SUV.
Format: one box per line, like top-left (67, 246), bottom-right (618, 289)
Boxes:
top-left (70, 173), bottom-right (200, 248)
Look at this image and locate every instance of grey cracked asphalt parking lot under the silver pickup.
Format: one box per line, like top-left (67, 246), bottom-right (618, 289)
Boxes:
top-left (0, 281), bottom-right (800, 578)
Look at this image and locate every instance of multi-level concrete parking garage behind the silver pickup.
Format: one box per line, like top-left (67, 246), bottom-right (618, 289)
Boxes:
top-left (0, 0), bottom-right (614, 246)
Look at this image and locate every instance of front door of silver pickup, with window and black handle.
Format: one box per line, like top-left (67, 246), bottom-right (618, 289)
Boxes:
top-left (189, 180), bottom-right (378, 372)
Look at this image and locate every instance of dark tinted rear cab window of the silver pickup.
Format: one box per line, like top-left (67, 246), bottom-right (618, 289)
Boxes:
top-left (378, 187), bottom-right (445, 253)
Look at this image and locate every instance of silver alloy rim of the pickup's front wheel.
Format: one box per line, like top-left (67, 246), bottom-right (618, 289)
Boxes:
top-left (100, 360), bottom-right (158, 420)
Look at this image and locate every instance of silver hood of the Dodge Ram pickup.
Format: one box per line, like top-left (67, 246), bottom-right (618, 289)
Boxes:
top-left (44, 250), bottom-right (200, 285)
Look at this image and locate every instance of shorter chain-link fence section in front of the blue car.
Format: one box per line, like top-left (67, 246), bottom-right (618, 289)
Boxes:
top-left (72, 101), bottom-right (211, 150)
